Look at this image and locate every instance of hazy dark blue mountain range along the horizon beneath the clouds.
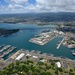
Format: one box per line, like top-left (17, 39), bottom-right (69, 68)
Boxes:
top-left (0, 12), bottom-right (75, 22)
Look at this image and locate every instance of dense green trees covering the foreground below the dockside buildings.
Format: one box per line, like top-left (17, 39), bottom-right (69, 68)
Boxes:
top-left (0, 58), bottom-right (75, 75)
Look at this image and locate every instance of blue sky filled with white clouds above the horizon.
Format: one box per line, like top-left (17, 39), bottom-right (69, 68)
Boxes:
top-left (0, 0), bottom-right (75, 14)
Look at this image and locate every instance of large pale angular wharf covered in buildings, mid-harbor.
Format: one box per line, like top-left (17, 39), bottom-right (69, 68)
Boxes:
top-left (29, 32), bottom-right (58, 45)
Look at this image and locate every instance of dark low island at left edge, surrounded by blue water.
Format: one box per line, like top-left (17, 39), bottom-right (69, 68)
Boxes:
top-left (0, 28), bottom-right (19, 36)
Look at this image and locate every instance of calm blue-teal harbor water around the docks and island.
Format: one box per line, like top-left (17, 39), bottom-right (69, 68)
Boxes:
top-left (0, 24), bottom-right (75, 59)
